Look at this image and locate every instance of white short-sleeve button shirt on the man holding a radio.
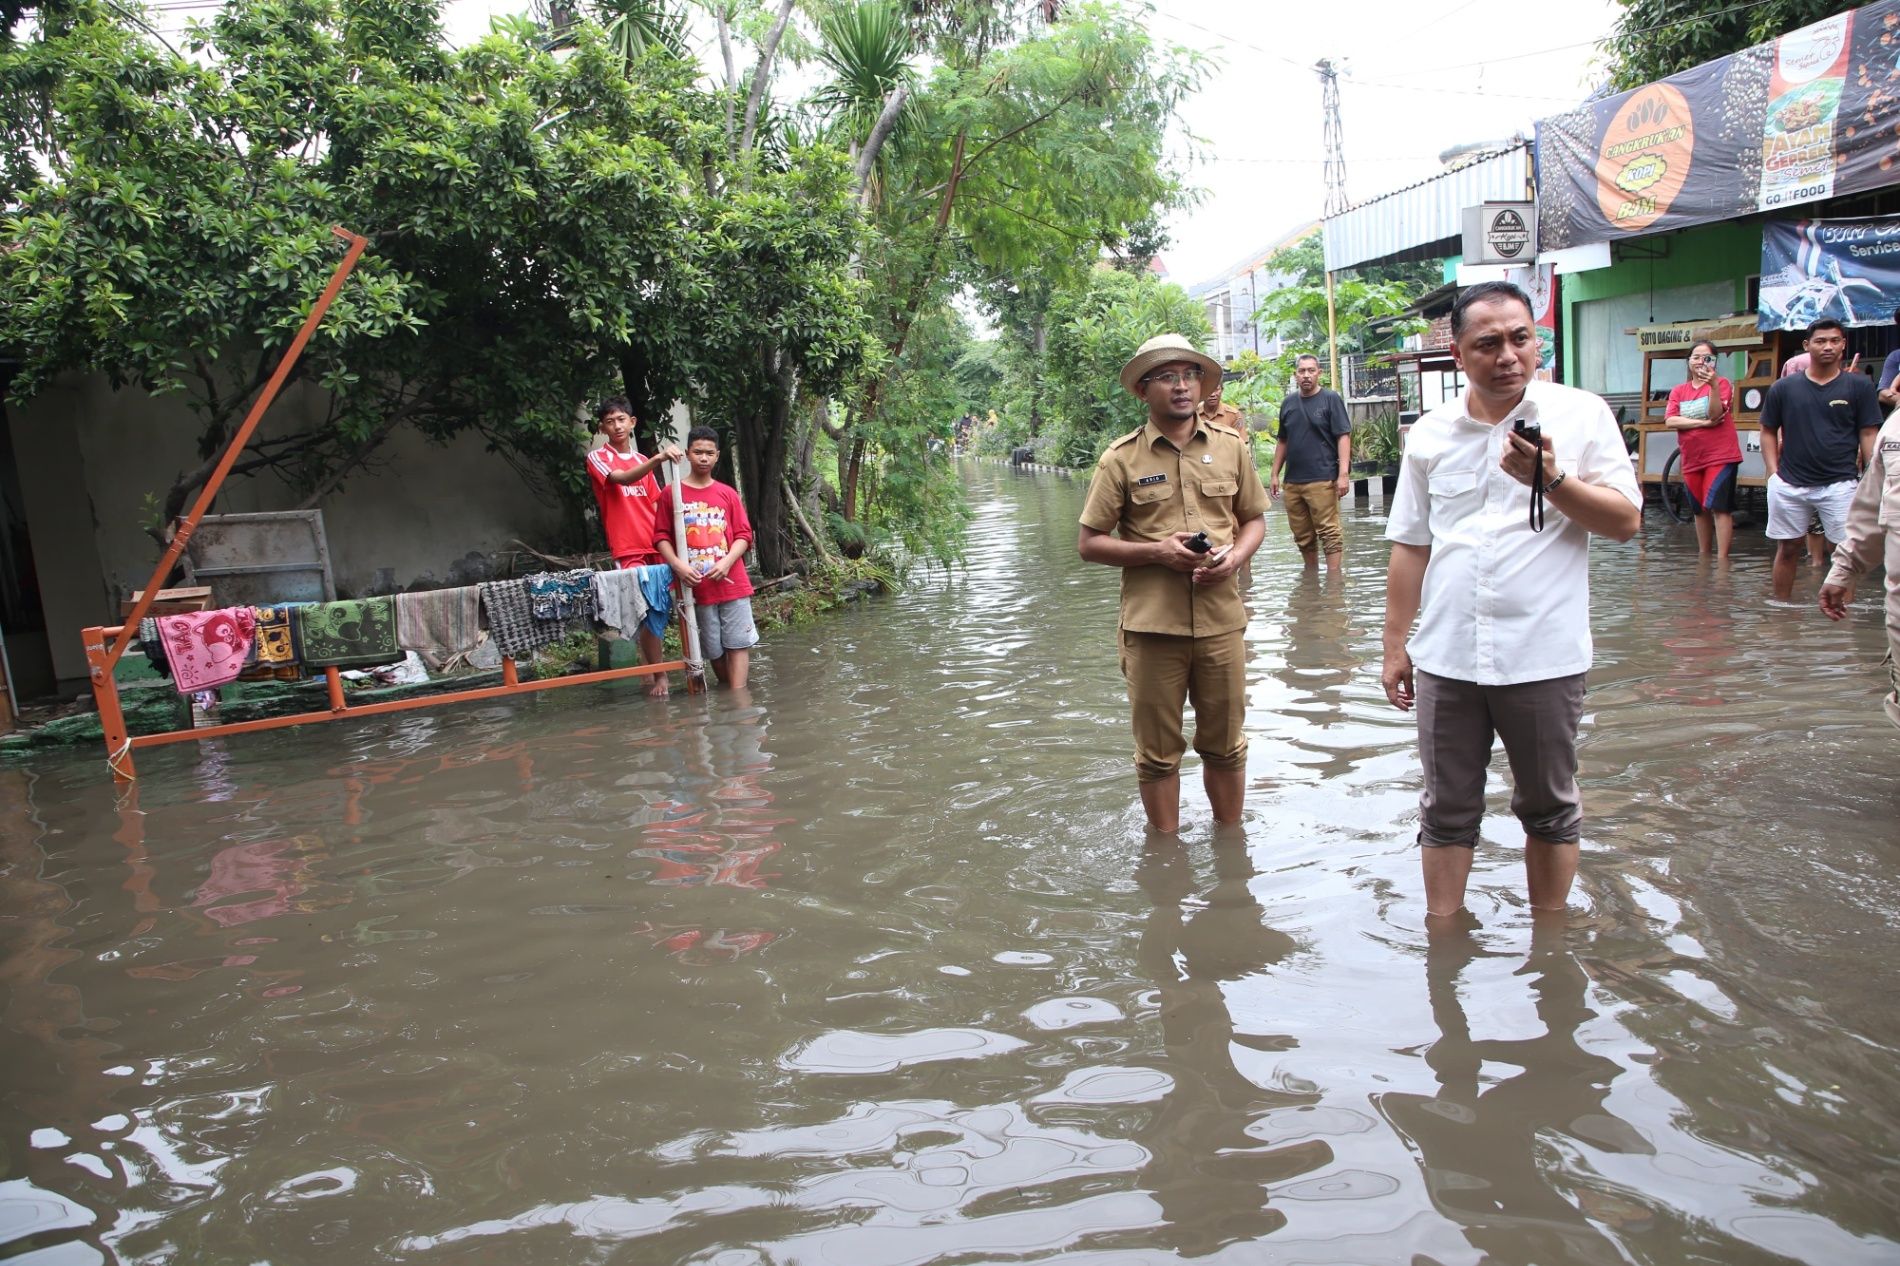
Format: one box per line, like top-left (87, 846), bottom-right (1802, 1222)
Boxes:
top-left (1385, 382), bottom-right (1644, 686)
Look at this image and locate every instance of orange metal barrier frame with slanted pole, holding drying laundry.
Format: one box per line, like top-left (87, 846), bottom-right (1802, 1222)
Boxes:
top-left (80, 228), bottom-right (705, 781)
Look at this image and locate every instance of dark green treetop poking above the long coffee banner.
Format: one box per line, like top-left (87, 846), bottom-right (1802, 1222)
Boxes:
top-left (1604, 0), bottom-right (1858, 91)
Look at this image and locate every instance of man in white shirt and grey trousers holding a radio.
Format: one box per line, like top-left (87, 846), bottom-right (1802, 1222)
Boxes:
top-left (1381, 281), bottom-right (1644, 918)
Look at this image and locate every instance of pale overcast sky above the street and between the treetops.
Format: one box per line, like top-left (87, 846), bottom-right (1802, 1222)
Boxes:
top-left (319, 0), bottom-right (1617, 285)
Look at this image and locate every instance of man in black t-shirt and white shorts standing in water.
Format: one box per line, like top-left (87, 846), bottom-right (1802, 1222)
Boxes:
top-left (1761, 317), bottom-right (1881, 601)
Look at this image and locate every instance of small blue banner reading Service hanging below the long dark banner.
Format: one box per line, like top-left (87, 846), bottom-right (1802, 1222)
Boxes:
top-left (1758, 215), bottom-right (1900, 331)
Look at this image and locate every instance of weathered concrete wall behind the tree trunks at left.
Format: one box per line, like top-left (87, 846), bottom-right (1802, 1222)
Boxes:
top-left (8, 374), bottom-right (580, 682)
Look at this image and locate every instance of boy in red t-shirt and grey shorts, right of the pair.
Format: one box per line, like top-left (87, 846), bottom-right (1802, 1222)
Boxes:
top-left (654, 426), bottom-right (758, 690)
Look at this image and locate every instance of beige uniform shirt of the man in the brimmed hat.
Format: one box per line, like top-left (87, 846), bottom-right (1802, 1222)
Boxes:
top-left (1081, 418), bottom-right (1267, 637)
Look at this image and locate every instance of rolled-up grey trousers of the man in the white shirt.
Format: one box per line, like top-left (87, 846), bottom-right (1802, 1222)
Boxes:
top-left (1416, 671), bottom-right (1583, 848)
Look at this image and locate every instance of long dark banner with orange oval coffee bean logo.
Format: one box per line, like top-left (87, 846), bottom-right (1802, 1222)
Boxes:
top-left (1537, 0), bottom-right (1900, 251)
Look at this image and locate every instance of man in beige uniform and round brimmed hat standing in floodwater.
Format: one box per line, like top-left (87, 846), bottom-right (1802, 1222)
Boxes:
top-left (1075, 335), bottom-right (1267, 833)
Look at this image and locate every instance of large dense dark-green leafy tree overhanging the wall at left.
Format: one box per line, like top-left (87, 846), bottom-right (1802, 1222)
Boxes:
top-left (0, 0), bottom-right (863, 566)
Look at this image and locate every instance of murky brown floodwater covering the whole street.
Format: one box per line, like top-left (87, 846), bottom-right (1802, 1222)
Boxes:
top-left (0, 466), bottom-right (1900, 1266)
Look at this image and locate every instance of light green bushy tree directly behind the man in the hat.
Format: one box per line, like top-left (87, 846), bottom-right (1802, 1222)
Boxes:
top-left (1045, 268), bottom-right (1212, 466)
